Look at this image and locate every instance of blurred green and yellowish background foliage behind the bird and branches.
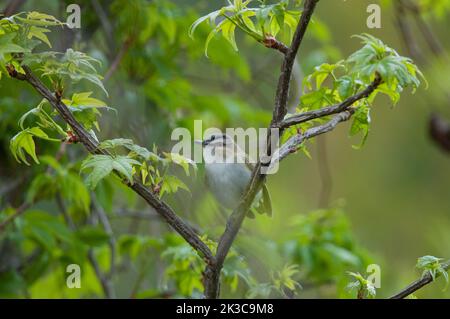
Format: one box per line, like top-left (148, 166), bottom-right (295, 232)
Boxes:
top-left (0, 0), bottom-right (450, 298)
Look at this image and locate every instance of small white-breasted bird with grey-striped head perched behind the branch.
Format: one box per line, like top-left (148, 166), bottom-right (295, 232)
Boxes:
top-left (195, 134), bottom-right (272, 218)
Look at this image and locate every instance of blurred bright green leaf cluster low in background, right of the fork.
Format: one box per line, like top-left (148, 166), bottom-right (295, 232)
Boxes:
top-left (281, 208), bottom-right (370, 292)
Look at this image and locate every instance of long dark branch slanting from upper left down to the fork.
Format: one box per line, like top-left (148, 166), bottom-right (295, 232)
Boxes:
top-left (10, 65), bottom-right (215, 264)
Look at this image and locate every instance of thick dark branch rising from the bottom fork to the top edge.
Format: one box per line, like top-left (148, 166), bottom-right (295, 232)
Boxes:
top-left (204, 0), bottom-right (319, 299)
